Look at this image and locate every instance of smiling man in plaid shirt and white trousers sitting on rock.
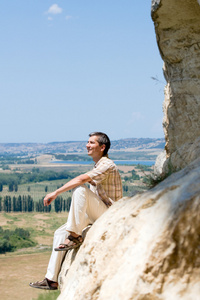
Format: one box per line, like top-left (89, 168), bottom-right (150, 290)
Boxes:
top-left (30, 132), bottom-right (122, 290)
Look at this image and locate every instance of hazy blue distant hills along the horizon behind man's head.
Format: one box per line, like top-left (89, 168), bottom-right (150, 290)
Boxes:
top-left (0, 138), bottom-right (165, 155)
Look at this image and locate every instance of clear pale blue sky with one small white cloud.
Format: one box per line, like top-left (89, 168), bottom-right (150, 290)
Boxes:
top-left (0, 0), bottom-right (165, 143)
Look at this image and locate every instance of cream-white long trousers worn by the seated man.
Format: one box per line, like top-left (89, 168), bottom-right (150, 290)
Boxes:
top-left (45, 185), bottom-right (108, 282)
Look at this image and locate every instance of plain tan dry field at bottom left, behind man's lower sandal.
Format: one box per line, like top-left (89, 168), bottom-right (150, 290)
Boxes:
top-left (0, 252), bottom-right (57, 300)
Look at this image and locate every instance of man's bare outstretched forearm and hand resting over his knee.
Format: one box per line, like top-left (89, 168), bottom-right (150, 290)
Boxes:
top-left (43, 174), bottom-right (91, 206)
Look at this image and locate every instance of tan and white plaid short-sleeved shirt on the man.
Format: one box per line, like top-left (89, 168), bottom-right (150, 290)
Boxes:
top-left (86, 156), bottom-right (123, 206)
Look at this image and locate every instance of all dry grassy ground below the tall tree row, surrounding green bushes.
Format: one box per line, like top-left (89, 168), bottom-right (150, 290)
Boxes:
top-left (0, 213), bottom-right (67, 300)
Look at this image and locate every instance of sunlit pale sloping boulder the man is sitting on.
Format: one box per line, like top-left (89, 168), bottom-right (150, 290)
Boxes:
top-left (58, 159), bottom-right (200, 300)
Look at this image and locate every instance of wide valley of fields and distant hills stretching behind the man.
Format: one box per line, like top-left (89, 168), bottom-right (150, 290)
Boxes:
top-left (0, 139), bottom-right (164, 300)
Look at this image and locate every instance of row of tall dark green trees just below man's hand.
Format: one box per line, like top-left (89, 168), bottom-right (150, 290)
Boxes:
top-left (0, 195), bottom-right (71, 213)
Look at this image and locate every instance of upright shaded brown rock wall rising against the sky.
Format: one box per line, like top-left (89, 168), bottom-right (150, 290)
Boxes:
top-left (152, 0), bottom-right (200, 172)
